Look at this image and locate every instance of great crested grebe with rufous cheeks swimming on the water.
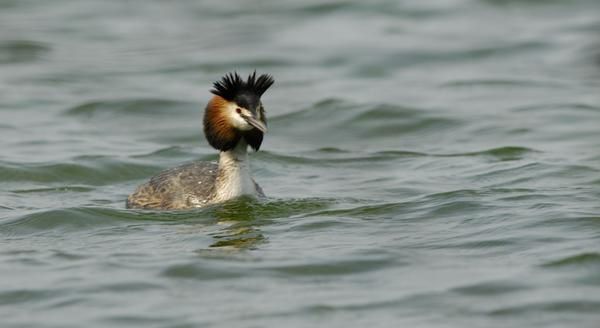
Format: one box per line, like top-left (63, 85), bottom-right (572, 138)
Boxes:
top-left (126, 71), bottom-right (275, 210)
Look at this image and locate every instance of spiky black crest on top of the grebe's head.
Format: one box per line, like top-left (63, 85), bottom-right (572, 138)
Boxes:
top-left (210, 71), bottom-right (275, 101)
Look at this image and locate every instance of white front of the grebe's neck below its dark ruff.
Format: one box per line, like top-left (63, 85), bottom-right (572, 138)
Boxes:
top-left (214, 139), bottom-right (257, 202)
